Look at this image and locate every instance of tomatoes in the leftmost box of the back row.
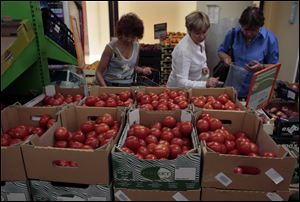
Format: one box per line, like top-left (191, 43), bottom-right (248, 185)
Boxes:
top-left (43, 93), bottom-right (83, 106)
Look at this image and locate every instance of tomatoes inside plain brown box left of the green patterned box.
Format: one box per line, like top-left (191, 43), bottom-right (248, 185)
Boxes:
top-left (54, 113), bottom-right (120, 149)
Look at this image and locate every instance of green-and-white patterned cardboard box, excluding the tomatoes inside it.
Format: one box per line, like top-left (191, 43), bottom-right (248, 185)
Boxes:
top-left (112, 109), bottom-right (201, 190)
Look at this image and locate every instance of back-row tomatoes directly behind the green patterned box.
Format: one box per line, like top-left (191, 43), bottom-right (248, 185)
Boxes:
top-left (137, 89), bottom-right (189, 111)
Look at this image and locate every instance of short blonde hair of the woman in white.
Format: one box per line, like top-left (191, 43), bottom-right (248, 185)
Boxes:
top-left (185, 11), bottom-right (210, 32)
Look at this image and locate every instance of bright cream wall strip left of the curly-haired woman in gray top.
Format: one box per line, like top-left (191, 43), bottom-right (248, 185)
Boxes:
top-left (85, 1), bottom-right (109, 64)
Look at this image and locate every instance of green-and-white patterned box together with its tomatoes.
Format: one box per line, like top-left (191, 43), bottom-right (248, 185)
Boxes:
top-left (112, 109), bottom-right (201, 190)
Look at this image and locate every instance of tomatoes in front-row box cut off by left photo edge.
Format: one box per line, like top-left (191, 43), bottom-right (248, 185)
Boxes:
top-left (1, 115), bottom-right (56, 146)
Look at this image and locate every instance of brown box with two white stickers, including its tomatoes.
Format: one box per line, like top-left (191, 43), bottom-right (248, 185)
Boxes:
top-left (195, 111), bottom-right (296, 191)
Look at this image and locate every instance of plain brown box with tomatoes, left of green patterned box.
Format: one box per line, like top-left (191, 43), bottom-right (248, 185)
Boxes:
top-left (22, 105), bottom-right (124, 185)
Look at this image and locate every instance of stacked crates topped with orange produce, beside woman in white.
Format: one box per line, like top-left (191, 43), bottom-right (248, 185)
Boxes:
top-left (160, 32), bottom-right (185, 85)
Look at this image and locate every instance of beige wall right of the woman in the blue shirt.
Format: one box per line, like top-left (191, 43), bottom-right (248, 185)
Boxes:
top-left (264, 1), bottom-right (299, 82)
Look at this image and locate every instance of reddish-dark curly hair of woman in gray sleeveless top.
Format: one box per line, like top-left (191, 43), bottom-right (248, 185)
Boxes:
top-left (117, 13), bottom-right (144, 39)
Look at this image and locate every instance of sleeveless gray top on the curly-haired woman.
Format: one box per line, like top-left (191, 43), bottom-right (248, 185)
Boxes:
top-left (103, 38), bottom-right (139, 84)
